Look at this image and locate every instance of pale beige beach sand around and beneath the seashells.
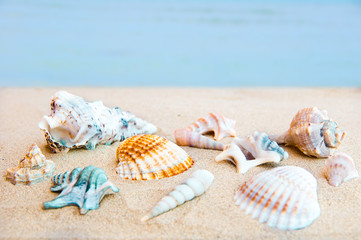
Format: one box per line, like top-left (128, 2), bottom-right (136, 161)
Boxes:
top-left (0, 88), bottom-right (361, 239)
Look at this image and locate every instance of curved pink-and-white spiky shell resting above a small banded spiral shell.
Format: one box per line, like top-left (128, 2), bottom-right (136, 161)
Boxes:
top-left (186, 113), bottom-right (236, 141)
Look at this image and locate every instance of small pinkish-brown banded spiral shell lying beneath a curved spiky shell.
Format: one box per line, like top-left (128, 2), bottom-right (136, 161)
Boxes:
top-left (174, 128), bottom-right (224, 150)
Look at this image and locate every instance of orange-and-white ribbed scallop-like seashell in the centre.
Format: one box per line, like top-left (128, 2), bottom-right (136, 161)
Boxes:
top-left (116, 134), bottom-right (193, 180)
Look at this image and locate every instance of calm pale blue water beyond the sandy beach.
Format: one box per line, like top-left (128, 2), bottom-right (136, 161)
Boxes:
top-left (0, 0), bottom-right (361, 86)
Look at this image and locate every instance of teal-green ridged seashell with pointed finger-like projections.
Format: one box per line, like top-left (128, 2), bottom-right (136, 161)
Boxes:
top-left (44, 165), bottom-right (119, 214)
